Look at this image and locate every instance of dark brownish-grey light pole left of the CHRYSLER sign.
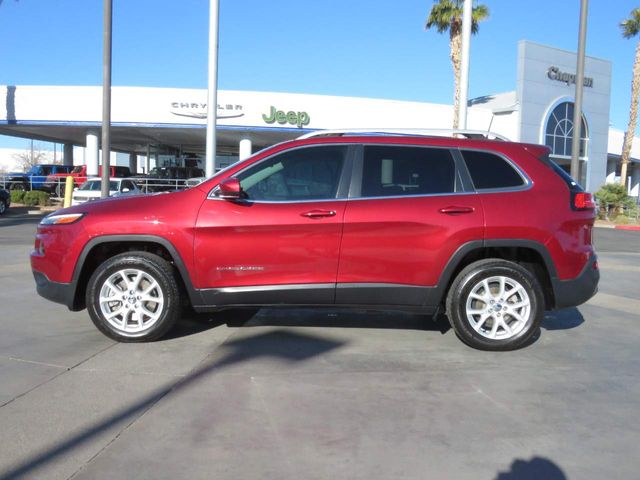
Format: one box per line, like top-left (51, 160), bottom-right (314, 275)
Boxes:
top-left (100, 0), bottom-right (113, 198)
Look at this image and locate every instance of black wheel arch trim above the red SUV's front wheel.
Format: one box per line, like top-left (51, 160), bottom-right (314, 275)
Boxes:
top-left (70, 234), bottom-right (203, 308)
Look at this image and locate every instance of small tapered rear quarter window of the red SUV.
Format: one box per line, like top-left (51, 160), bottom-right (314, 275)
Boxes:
top-left (461, 150), bottom-right (524, 190)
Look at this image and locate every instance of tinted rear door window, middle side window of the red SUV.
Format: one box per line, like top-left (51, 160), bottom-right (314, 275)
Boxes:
top-left (361, 146), bottom-right (456, 197)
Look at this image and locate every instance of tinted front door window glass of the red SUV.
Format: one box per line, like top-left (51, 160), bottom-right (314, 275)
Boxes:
top-left (236, 146), bottom-right (346, 201)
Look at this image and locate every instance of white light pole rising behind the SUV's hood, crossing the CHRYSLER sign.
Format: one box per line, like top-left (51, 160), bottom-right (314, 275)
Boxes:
top-left (205, 0), bottom-right (220, 178)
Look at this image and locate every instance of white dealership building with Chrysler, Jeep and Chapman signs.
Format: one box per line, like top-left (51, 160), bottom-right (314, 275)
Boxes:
top-left (0, 41), bottom-right (640, 197)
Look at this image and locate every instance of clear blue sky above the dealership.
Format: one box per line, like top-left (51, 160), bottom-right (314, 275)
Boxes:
top-left (0, 0), bottom-right (640, 147)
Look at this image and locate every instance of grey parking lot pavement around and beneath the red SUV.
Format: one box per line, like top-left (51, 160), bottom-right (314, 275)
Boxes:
top-left (0, 211), bottom-right (640, 480)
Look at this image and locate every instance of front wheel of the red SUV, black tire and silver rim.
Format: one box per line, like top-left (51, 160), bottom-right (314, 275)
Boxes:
top-left (86, 252), bottom-right (181, 342)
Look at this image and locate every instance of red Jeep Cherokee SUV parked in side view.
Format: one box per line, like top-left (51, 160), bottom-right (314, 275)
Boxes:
top-left (31, 134), bottom-right (599, 350)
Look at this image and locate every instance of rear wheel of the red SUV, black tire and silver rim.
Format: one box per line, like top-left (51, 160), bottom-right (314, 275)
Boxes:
top-left (446, 258), bottom-right (544, 351)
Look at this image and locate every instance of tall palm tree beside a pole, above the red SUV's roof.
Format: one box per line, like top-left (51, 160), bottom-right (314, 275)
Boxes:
top-left (425, 0), bottom-right (489, 129)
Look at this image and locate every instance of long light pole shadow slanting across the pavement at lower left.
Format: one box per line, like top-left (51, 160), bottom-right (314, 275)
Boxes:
top-left (0, 329), bottom-right (346, 480)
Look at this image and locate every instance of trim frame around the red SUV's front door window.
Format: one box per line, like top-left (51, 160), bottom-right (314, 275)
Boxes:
top-left (207, 143), bottom-right (358, 204)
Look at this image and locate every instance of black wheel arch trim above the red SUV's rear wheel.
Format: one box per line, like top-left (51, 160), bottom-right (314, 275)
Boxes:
top-left (427, 238), bottom-right (558, 305)
